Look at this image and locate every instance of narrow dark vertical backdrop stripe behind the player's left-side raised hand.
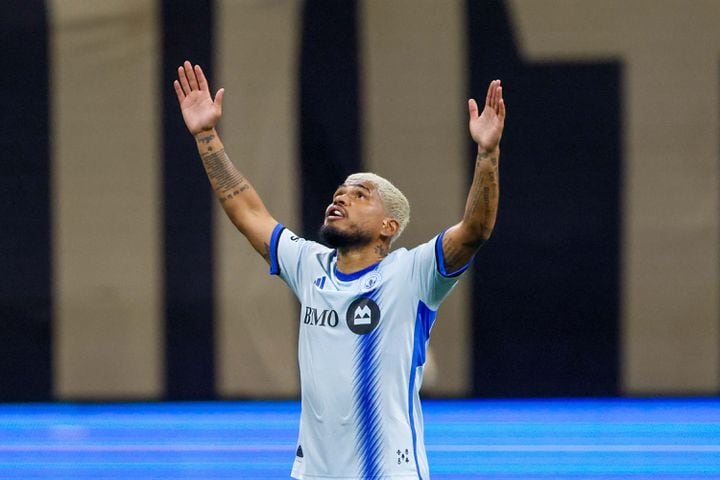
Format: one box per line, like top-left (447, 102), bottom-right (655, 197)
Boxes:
top-left (162, 0), bottom-right (215, 400)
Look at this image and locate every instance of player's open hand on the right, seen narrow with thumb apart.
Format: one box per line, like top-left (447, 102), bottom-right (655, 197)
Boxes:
top-left (468, 80), bottom-right (505, 152)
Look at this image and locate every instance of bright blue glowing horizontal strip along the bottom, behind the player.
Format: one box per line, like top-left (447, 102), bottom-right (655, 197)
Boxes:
top-left (0, 398), bottom-right (720, 480)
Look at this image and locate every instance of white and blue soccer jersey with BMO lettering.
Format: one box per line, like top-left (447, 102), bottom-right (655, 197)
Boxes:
top-left (270, 225), bottom-right (467, 480)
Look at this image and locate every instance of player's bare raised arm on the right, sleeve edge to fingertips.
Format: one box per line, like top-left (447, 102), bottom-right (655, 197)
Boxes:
top-left (442, 80), bottom-right (505, 273)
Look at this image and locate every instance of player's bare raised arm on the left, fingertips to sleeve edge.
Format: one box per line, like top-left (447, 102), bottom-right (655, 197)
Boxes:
top-left (174, 61), bottom-right (278, 262)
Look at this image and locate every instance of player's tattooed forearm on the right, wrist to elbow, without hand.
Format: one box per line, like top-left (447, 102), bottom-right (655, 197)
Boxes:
top-left (462, 148), bottom-right (500, 244)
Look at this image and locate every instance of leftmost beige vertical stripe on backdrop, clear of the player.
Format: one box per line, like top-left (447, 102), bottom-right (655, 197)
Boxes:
top-left (49, 0), bottom-right (163, 398)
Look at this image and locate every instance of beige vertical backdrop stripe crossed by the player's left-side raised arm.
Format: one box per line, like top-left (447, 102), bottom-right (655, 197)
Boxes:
top-left (214, 0), bottom-right (301, 396)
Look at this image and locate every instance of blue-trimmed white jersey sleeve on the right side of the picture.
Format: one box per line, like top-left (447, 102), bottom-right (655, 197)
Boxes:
top-left (411, 231), bottom-right (472, 310)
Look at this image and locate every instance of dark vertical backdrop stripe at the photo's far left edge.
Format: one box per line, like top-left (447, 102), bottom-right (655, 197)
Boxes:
top-left (0, 0), bottom-right (52, 401)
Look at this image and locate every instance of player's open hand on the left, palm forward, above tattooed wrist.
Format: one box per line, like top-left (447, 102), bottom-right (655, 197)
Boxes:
top-left (173, 61), bottom-right (225, 135)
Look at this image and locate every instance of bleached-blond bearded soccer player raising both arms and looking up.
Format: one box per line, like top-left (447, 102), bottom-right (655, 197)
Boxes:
top-left (174, 61), bottom-right (505, 480)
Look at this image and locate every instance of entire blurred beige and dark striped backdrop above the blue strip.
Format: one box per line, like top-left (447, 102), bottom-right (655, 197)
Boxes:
top-left (0, 0), bottom-right (720, 478)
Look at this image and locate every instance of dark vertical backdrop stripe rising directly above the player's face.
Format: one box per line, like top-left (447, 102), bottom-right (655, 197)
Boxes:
top-left (300, 0), bottom-right (362, 238)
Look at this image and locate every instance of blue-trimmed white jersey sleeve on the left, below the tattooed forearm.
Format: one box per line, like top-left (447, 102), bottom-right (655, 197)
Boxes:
top-left (270, 223), bottom-right (326, 295)
